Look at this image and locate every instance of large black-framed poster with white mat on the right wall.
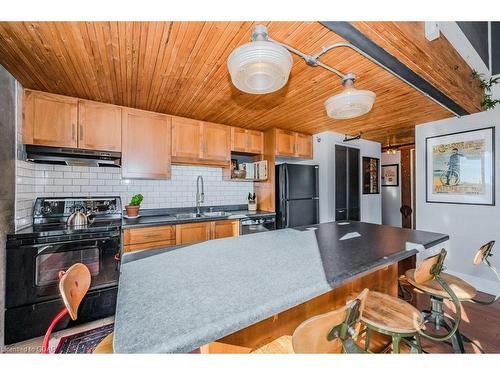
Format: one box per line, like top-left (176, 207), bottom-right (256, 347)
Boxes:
top-left (425, 127), bottom-right (495, 206)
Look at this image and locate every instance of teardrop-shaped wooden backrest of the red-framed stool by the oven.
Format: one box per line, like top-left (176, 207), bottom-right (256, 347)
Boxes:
top-left (59, 263), bottom-right (91, 320)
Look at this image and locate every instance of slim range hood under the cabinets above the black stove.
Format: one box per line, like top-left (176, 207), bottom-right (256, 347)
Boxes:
top-left (26, 145), bottom-right (121, 168)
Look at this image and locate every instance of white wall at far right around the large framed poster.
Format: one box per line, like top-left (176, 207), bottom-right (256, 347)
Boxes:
top-left (416, 108), bottom-right (500, 293)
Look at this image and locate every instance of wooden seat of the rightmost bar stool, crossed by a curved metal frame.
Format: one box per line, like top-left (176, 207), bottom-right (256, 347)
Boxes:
top-left (405, 269), bottom-right (477, 301)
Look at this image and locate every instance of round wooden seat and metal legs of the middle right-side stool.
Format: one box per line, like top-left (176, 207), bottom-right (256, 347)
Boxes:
top-left (361, 291), bottom-right (424, 354)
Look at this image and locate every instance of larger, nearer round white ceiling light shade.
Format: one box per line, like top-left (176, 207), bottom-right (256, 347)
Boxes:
top-left (227, 40), bottom-right (293, 94)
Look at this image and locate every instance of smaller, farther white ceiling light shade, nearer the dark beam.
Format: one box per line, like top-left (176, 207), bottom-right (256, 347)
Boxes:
top-left (325, 80), bottom-right (376, 120)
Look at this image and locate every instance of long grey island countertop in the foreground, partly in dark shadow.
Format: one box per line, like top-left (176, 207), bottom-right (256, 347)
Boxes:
top-left (114, 222), bottom-right (448, 353)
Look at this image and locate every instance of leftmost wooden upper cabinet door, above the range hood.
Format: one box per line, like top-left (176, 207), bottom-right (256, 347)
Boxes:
top-left (23, 90), bottom-right (78, 148)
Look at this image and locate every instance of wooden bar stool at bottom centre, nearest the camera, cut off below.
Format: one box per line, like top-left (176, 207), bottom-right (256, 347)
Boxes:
top-left (253, 289), bottom-right (368, 354)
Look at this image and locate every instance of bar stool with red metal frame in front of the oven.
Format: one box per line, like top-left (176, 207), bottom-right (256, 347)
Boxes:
top-left (42, 263), bottom-right (112, 354)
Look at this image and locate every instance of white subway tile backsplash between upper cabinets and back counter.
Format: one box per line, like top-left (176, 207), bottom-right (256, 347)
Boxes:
top-left (16, 160), bottom-right (253, 228)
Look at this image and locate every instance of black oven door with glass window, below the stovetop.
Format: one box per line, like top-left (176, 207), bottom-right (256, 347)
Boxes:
top-left (5, 236), bottom-right (120, 308)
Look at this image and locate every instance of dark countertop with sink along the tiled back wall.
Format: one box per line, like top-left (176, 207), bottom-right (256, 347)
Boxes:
top-left (122, 205), bottom-right (276, 229)
